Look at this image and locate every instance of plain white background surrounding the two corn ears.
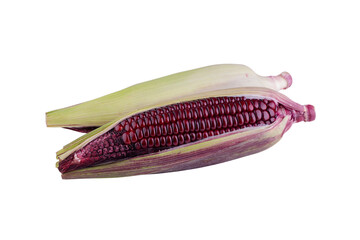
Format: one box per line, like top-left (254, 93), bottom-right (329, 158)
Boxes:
top-left (0, 0), bottom-right (360, 240)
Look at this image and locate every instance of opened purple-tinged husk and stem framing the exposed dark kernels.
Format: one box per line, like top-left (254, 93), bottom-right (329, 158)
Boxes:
top-left (57, 87), bottom-right (315, 179)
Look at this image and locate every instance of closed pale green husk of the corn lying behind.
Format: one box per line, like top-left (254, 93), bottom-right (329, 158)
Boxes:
top-left (46, 64), bottom-right (291, 127)
